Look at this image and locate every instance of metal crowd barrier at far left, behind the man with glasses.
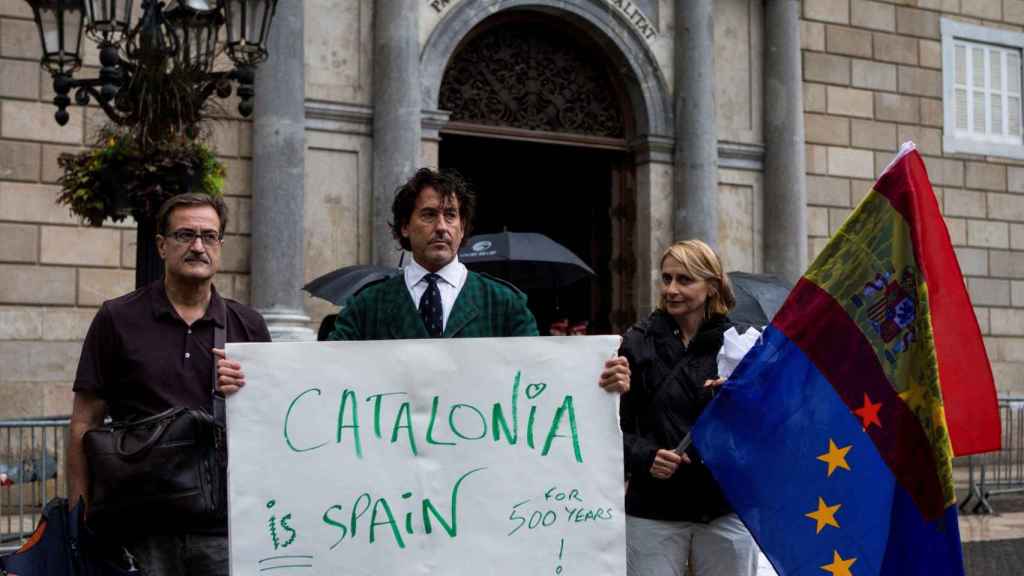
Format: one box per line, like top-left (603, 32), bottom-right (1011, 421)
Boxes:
top-left (0, 416), bottom-right (69, 550)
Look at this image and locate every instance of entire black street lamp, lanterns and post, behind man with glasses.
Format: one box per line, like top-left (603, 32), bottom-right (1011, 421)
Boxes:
top-left (26, 0), bottom-right (280, 286)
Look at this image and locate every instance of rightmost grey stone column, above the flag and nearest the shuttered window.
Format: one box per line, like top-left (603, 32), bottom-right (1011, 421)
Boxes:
top-left (762, 0), bottom-right (807, 282)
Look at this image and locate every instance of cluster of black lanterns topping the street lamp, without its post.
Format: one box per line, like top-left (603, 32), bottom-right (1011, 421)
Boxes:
top-left (26, 0), bottom-right (278, 129)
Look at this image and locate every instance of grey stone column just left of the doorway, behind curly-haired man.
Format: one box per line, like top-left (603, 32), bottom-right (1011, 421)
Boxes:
top-left (371, 0), bottom-right (423, 265)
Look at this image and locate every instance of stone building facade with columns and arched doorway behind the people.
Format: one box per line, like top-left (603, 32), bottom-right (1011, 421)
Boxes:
top-left (0, 0), bottom-right (1024, 418)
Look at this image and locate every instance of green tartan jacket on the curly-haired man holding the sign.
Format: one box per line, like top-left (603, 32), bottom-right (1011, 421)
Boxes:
top-left (328, 271), bottom-right (538, 340)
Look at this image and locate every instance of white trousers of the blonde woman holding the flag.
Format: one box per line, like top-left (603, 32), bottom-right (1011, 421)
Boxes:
top-left (626, 513), bottom-right (759, 576)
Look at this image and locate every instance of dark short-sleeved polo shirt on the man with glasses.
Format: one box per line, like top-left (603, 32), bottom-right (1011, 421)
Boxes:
top-left (74, 280), bottom-right (270, 420)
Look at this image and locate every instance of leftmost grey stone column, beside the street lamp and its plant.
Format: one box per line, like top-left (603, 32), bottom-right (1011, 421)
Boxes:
top-left (251, 2), bottom-right (315, 340)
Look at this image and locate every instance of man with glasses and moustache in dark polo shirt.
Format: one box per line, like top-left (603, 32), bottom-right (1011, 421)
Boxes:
top-left (68, 194), bottom-right (270, 576)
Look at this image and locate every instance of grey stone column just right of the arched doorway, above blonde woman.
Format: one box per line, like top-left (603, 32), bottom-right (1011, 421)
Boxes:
top-left (674, 0), bottom-right (718, 247)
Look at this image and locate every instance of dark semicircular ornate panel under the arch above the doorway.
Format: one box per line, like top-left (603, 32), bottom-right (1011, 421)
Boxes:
top-left (437, 16), bottom-right (633, 141)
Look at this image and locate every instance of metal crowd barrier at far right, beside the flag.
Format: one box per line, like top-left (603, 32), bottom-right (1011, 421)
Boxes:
top-left (959, 398), bottom-right (1024, 513)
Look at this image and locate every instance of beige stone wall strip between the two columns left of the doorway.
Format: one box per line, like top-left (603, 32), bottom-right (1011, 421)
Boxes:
top-left (304, 0), bottom-right (374, 330)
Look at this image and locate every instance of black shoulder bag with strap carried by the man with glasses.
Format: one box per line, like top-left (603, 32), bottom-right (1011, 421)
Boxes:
top-left (84, 318), bottom-right (227, 532)
